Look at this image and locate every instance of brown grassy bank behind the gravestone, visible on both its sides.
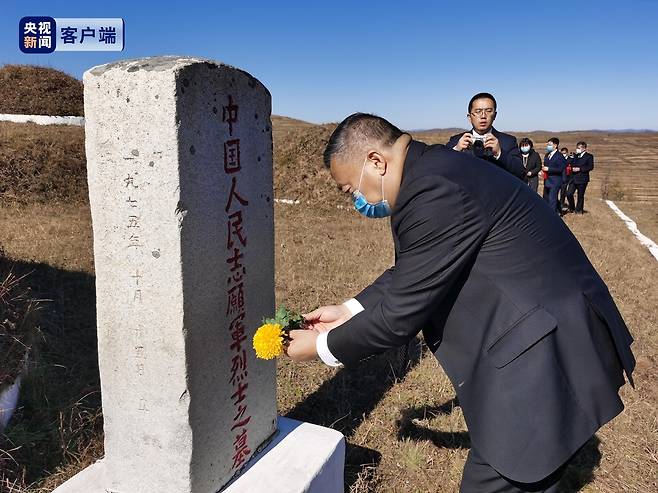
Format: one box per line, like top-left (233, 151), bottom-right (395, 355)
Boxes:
top-left (0, 116), bottom-right (345, 205)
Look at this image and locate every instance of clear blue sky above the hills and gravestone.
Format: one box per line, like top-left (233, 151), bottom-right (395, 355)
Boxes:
top-left (0, 0), bottom-right (658, 131)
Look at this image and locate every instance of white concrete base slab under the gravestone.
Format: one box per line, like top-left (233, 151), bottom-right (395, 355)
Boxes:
top-left (53, 417), bottom-right (345, 493)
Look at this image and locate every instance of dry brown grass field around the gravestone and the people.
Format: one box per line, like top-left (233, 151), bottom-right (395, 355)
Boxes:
top-left (0, 118), bottom-right (658, 493)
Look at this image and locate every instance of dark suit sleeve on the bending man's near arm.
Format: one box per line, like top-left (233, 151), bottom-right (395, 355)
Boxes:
top-left (327, 177), bottom-right (489, 365)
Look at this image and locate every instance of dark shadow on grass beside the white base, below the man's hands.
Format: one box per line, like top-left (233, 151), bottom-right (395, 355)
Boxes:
top-left (286, 339), bottom-right (422, 491)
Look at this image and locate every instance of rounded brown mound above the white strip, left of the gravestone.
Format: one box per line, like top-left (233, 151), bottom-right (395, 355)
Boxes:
top-left (0, 65), bottom-right (84, 116)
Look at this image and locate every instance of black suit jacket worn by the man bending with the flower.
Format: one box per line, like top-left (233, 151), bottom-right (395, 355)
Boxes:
top-left (327, 141), bottom-right (635, 482)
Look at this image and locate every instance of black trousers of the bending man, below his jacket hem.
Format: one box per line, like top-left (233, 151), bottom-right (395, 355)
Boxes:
top-left (459, 448), bottom-right (569, 493)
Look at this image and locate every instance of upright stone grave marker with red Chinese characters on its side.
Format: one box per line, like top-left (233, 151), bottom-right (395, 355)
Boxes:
top-left (58, 57), bottom-right (276, 493)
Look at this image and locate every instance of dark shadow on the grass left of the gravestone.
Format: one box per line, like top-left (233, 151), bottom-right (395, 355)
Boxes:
top-left (0, 256), bottom-right (102, 486)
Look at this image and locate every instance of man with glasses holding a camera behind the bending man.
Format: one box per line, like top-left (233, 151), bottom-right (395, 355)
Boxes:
top-left (446, 92), bottom-right (526, 180)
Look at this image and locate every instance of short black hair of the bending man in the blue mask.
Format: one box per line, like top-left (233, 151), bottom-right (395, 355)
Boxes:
top-left (323, 113), bottom-right (404, 168)
